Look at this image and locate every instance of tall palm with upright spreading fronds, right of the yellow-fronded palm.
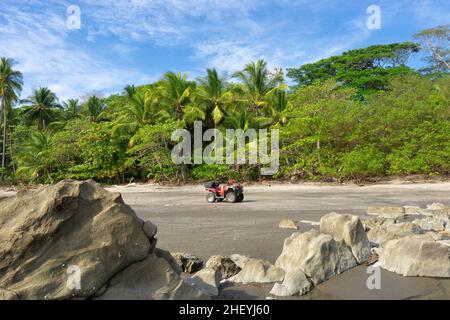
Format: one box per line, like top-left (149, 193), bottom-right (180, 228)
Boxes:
top-left (234, 60), bottom-right (283, 116)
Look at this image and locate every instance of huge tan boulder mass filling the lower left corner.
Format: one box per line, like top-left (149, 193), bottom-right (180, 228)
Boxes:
top-left (0, 180), bottom-right (208, 299)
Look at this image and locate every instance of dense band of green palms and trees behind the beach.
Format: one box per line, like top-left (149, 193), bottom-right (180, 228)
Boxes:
top-left (0, 27), bottom-right (450, 183)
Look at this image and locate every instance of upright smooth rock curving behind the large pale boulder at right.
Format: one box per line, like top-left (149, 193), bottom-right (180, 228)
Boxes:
top-left (320, 212), bottom-right (370, 263)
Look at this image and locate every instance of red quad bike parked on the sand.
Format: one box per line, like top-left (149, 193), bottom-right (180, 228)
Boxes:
top-left (204, 180), bottom-right (244, 203)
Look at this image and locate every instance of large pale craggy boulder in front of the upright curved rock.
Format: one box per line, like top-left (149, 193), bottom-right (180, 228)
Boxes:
top-left (275, 229), bottom-right (357, 285)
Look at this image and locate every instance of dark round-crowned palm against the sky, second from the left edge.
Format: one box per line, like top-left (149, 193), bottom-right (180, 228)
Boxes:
top-left (22, 87), bottom-right (62, 131)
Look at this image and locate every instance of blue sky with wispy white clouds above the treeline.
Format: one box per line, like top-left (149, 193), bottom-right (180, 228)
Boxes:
top-left (0, 0), bottom-right (450, 100)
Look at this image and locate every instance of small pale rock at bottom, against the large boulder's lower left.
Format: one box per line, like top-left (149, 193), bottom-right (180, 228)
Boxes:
top-left (270, 270), bottom-right (313, 297)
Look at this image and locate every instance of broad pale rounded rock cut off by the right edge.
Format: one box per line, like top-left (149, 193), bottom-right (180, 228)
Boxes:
top-left (377, 236), bottom-right (450, 278)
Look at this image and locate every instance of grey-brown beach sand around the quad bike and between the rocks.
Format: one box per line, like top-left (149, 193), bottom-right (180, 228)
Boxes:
top-left (109, 182), bottom-right (450, 299)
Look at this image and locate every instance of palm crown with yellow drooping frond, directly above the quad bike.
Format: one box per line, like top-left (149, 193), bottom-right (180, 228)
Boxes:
top-left (197, 69), bottom-right (232, 126)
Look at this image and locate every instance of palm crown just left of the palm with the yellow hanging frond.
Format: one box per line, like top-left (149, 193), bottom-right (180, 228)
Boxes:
top-left (146, 72), bottom-right (205, 122)
